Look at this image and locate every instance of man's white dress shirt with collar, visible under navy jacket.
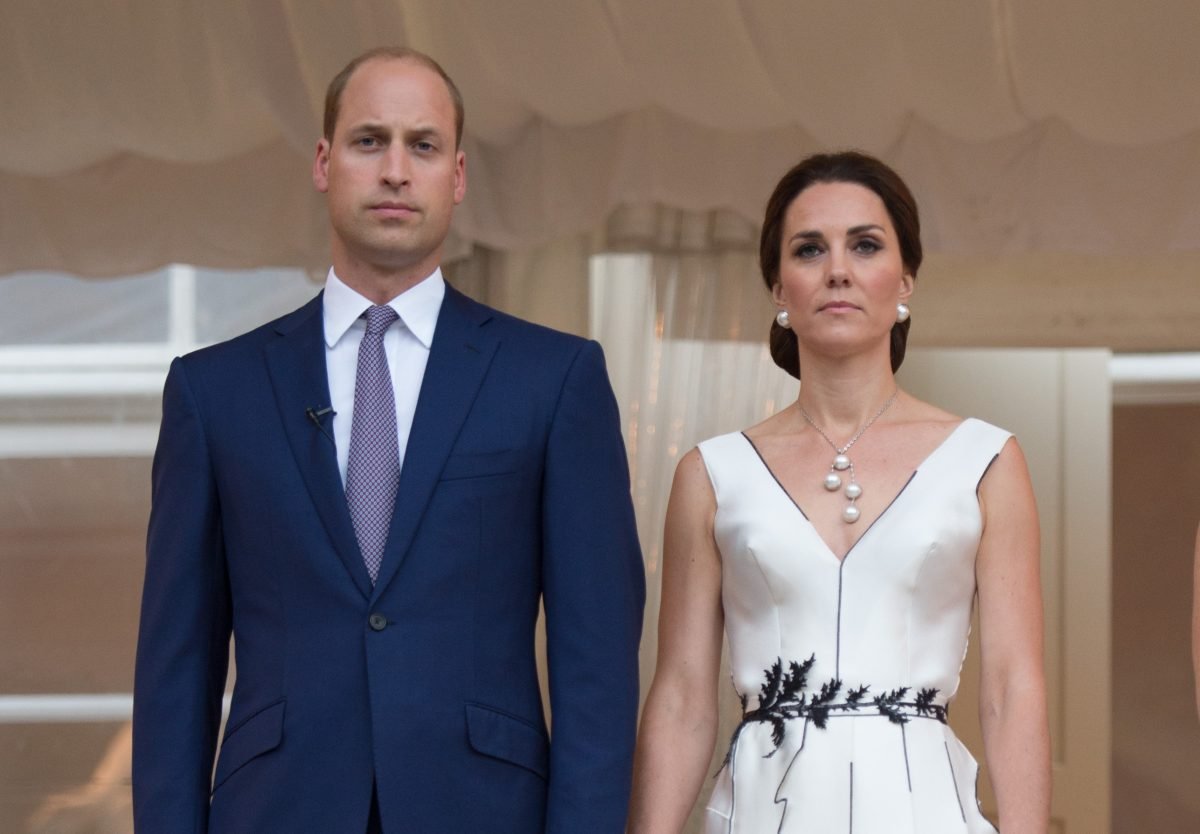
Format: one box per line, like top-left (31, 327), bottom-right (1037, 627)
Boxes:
top-left (323, 269), bottom-right (446, 487)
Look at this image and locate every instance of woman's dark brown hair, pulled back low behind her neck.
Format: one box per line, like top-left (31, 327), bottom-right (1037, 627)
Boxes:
top-left (758, 151), bottom-right (924, 379)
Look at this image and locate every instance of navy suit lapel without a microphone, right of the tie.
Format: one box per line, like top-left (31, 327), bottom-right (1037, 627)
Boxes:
top-left (367, 284), bottom-right (498, 596)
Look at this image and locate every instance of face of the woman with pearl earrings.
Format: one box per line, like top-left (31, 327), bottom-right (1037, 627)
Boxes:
top-left (772, 182), bottom-right (912, 356)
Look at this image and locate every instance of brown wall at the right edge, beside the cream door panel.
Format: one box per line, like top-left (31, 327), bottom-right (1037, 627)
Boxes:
top-left (1112, 406), bottom-right (1200, 834)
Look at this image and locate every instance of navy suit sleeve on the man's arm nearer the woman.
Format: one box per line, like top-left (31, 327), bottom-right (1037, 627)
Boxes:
top-left (542, 342), bottom-right (646, 834)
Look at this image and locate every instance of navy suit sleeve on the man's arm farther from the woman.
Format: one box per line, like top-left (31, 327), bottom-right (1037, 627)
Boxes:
top-left (133, 359), bottom-right (230, 834)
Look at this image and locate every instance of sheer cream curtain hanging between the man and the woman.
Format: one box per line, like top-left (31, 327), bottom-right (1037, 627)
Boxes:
top-left (590, 211), bottom-right (798, 832)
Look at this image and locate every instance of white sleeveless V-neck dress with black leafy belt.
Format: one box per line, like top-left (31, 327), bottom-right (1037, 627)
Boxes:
top-left (700, 419), bottom-right (1009, 834)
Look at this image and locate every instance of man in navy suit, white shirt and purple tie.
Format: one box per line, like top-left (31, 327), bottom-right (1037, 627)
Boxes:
top-left (133, 49), bottom-right (644, 834)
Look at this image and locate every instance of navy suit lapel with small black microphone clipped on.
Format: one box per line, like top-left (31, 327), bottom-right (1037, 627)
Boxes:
top-left (265, 295), bottom-right (371, 598)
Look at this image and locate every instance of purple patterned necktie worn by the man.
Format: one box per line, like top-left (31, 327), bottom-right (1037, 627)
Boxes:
top-left (346, 306), bottom-right (400, 584)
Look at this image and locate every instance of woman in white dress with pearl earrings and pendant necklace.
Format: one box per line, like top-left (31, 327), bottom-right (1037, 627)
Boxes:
top-left (630, 152), bottom-right (1050, 834)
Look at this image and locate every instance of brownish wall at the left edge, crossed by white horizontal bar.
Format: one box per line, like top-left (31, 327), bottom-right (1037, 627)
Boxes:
top-left (0, 458), bottom-right (150, 834)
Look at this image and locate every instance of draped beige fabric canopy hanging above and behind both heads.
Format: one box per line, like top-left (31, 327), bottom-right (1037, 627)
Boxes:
top-left (0, 0), bottom-right (1200, 275)
